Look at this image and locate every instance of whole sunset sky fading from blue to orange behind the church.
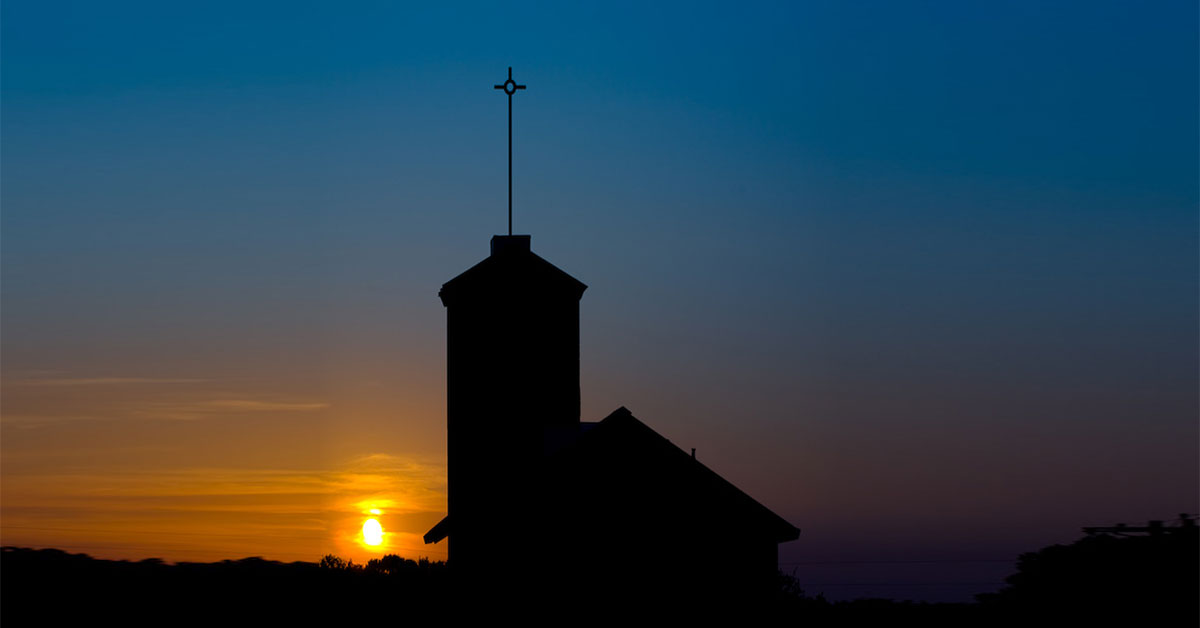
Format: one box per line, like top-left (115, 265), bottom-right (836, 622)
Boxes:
top-left (0, 0), bottom-right (1200, 600)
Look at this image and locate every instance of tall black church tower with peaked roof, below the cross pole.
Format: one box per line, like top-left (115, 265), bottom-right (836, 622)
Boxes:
top-left (431, 235), bottom-right (587, 573)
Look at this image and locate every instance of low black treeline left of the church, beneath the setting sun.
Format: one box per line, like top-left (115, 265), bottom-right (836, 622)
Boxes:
top-left (0, 548), bottom-right (449, 627)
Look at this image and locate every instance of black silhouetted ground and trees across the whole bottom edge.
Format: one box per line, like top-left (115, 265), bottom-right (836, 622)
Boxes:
top-left (0, 527), bottom-right (1200, 627)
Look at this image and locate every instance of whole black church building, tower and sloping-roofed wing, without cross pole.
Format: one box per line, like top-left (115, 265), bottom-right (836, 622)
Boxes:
top-left (425, 235), bottom-right (799, 609)
